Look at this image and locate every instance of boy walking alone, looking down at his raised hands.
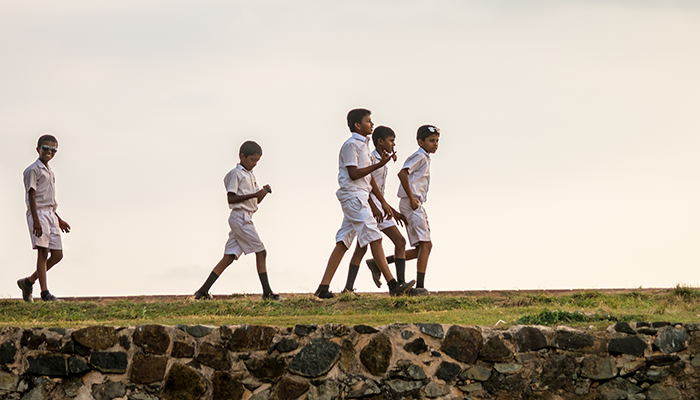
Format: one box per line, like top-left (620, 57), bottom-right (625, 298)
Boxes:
top-left (194, 140), bottom-right (280, 301)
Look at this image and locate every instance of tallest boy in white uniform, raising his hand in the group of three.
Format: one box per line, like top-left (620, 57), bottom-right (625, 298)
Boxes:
top-left (314, 108), bottom-right (415, 299)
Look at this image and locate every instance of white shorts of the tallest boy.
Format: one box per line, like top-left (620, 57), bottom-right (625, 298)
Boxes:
top-left (335, 197), bottom-right (382, 248)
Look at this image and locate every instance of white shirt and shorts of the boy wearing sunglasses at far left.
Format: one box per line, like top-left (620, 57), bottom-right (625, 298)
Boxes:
top-left (22, 159), bottom-right (63, 250)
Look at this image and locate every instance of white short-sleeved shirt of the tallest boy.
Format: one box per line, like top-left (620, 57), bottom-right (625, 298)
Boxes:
top-left (335, 132), bottom-right (372, 202)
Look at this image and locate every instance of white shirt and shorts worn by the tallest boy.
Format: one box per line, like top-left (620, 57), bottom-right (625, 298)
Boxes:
top-left (335, 132), bottom-right (382, 248)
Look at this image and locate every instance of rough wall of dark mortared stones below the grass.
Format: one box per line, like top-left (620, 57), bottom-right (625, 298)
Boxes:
top-left (0, 322), bottom-right (700, 400)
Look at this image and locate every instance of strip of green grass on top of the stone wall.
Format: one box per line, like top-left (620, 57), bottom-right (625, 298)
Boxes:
top-left (0, 285), bottom-right (700, 329)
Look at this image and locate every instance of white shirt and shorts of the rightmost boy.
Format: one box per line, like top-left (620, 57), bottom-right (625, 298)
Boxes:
top-left (398, 147), bottom-right (431, 246)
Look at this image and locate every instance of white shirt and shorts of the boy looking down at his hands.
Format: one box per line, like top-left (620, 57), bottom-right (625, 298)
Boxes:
top-left (224, 164), bottom-right (265, 258)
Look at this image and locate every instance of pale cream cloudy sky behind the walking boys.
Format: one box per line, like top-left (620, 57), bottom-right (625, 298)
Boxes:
top-left (0, 0), bottom-right (700, 298)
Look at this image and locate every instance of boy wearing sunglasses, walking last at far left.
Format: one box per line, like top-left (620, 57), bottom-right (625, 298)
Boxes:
top-left (17, 134), bottom-right (70, 302)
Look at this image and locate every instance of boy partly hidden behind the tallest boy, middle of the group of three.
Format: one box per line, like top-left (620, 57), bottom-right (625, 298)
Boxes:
top-left (343, 126), bottom-right (416, 293)
